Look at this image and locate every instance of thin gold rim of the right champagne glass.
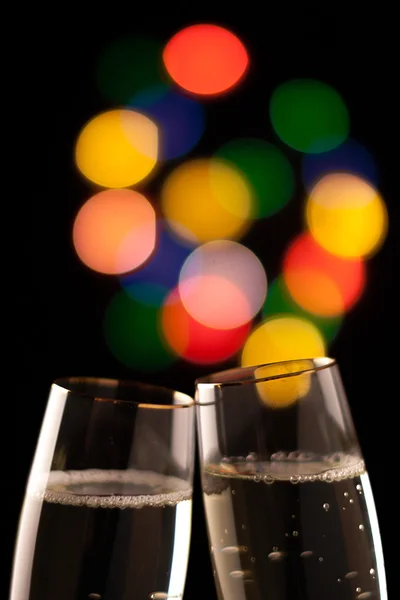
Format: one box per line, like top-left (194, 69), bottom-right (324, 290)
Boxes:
top-left (195, 356), bottom-right (337, 388)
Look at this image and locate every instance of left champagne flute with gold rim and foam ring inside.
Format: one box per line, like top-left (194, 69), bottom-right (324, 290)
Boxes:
top-left (10, 378), bottom-right (195, 600)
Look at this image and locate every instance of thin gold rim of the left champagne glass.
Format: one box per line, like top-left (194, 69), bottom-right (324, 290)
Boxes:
top-left (52, 376), bottom-right (195, 410)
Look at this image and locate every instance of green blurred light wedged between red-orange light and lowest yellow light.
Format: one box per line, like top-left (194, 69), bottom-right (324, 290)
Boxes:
top-left (262, 275), bottom-right (343, 342)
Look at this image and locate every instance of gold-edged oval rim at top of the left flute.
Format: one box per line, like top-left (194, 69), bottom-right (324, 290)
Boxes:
top-left (51, 375), bottom-right (195, 410)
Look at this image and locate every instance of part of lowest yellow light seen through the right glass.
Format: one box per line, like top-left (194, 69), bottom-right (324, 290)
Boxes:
top-left (254, 360), bottom-right (312, 408)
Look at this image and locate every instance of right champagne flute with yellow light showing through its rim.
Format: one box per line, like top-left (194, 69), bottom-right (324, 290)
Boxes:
top-left (196, 357), bottom-right (387, 600)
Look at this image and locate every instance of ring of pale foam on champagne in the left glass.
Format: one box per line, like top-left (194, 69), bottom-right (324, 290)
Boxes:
top-left (28, 469), bottom-right (192, 509)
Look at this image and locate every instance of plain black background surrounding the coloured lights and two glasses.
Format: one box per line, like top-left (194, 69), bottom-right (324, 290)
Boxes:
top-left (7, 3), bottom-right (400, 599)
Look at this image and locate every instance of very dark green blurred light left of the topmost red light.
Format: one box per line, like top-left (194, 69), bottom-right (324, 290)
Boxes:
top-left (96, 35), bottom-right (165, 105)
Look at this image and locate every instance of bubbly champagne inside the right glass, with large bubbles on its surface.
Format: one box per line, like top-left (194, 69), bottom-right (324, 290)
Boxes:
top-left (203, 453), bottom-right (387, 600)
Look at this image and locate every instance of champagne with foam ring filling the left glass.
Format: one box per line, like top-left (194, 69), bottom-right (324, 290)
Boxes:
top-left (11, 470), bottom-right (192, 600)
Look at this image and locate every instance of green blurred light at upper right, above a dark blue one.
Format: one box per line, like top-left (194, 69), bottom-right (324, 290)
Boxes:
top-left (270, 79), bottom-right (349, 153)
